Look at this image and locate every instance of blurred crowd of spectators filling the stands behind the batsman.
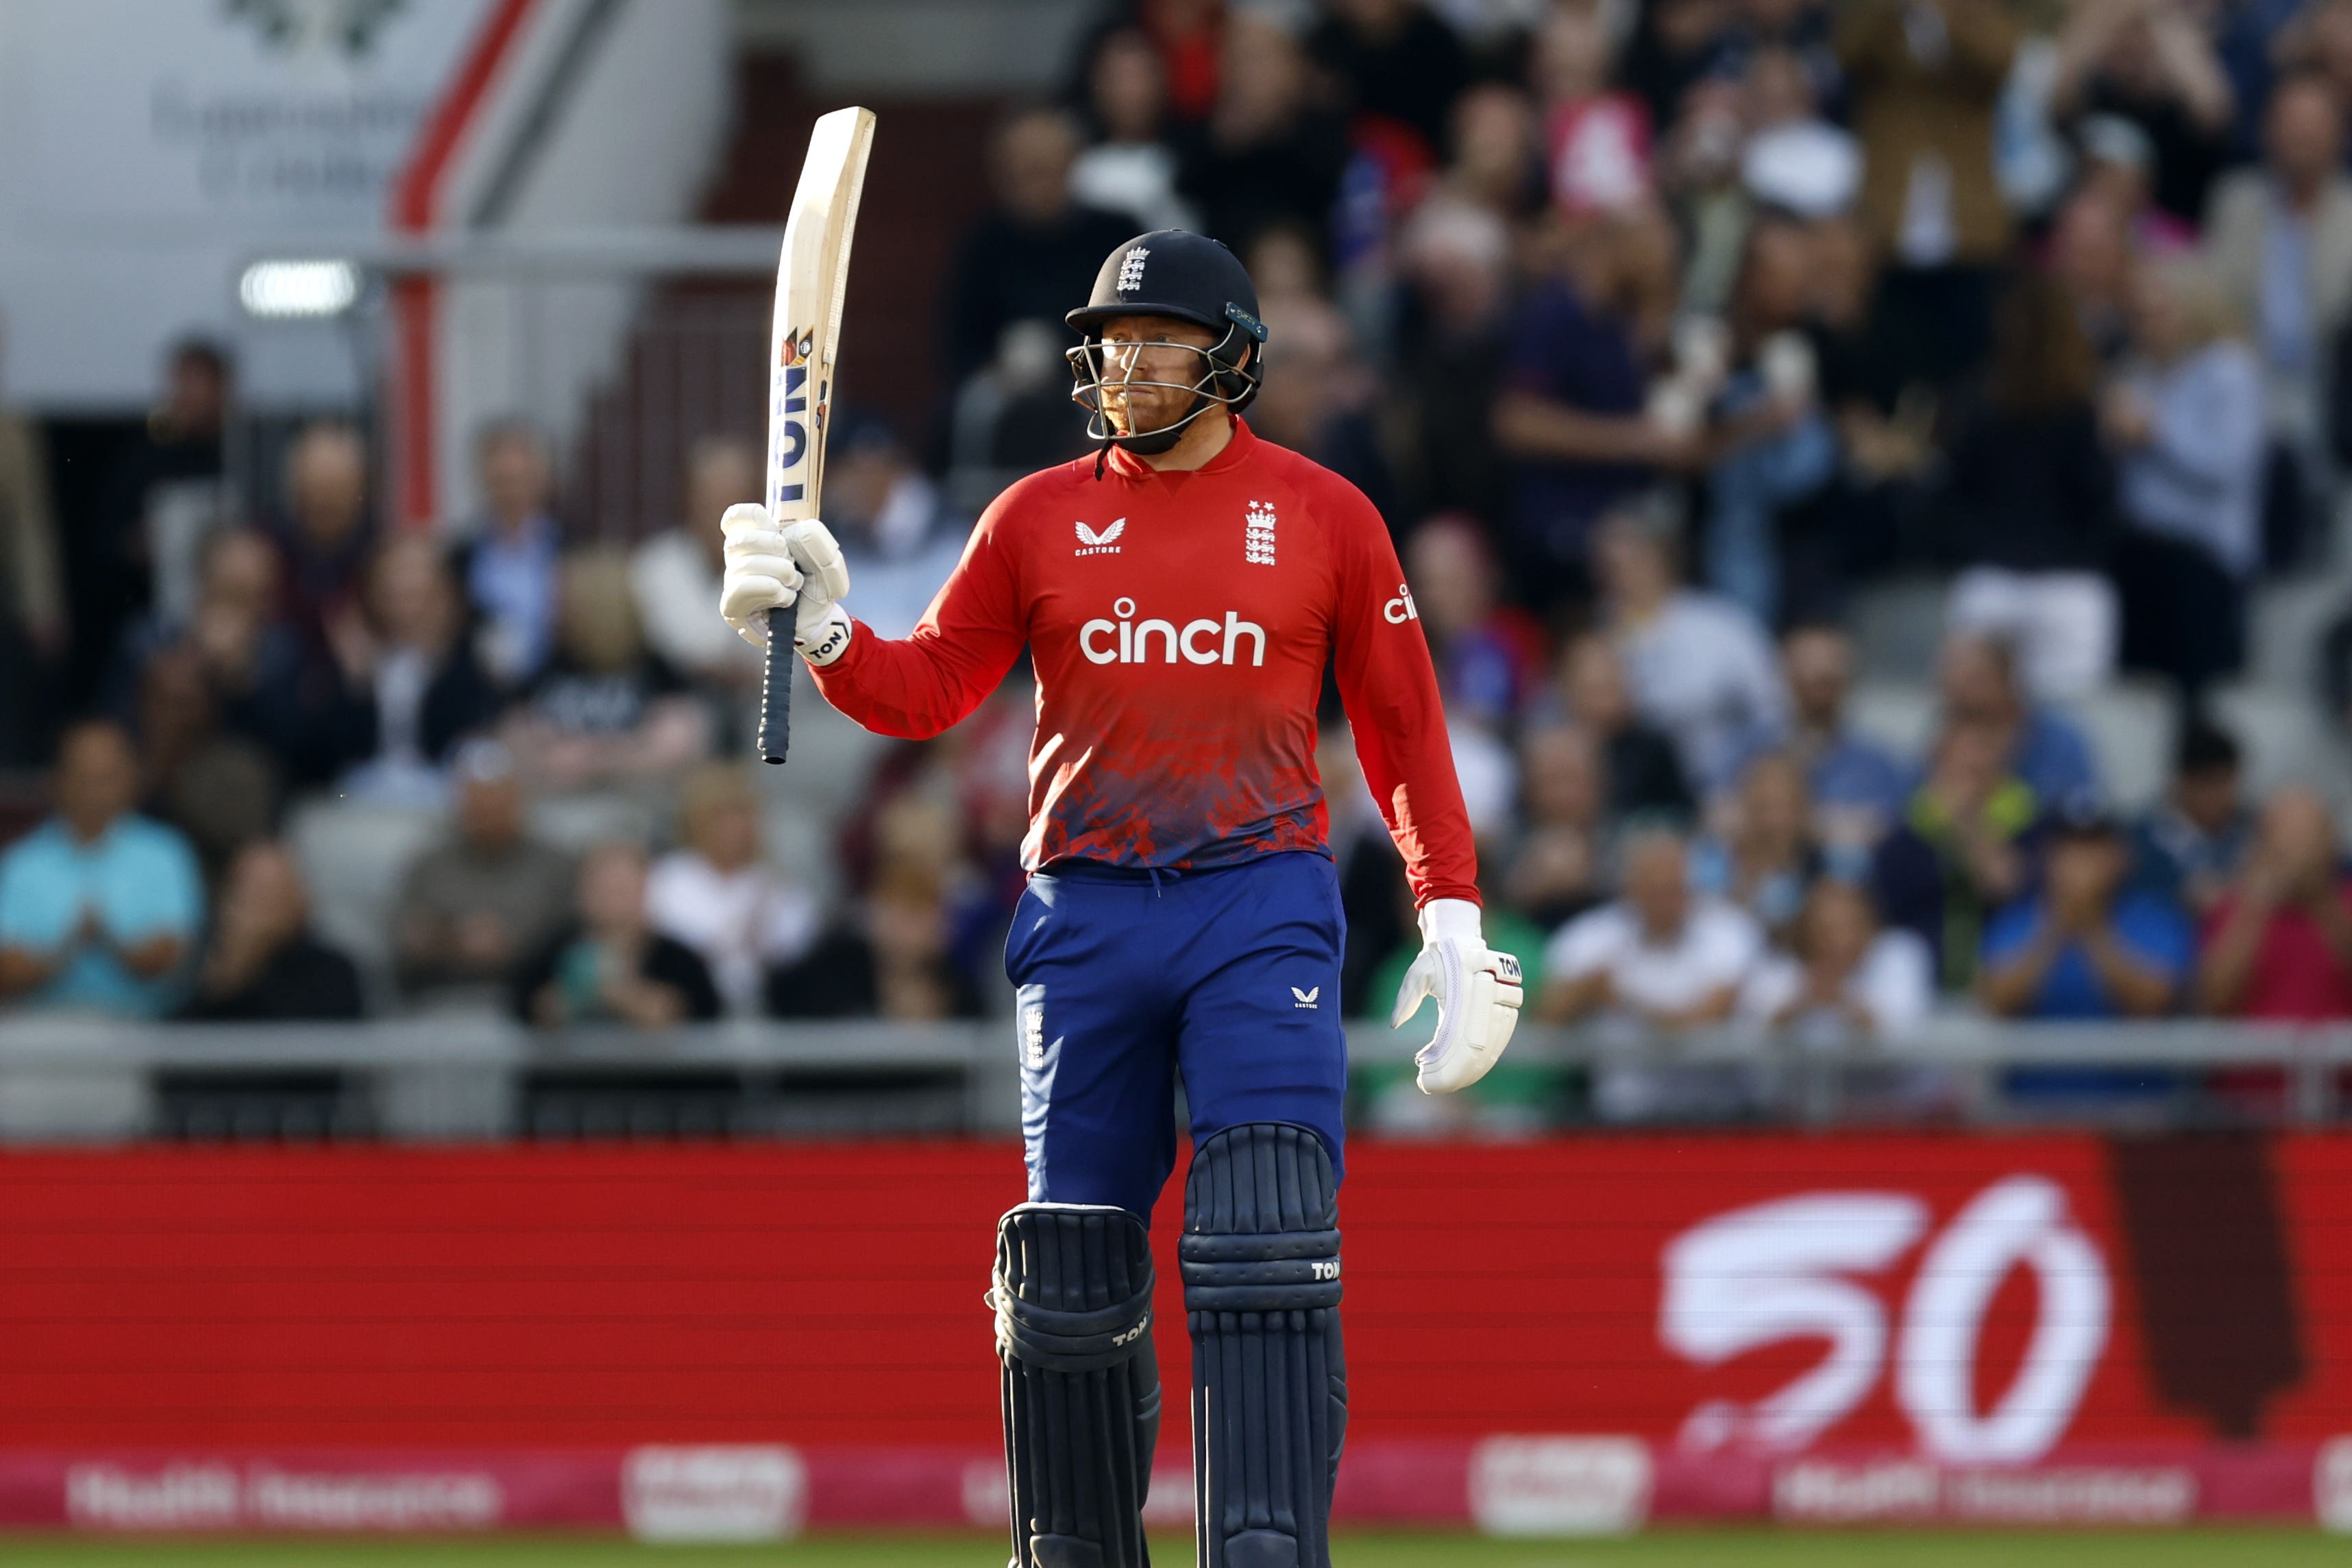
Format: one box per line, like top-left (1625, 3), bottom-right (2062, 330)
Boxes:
top-left (0, 0), bottom-right (2352, 1116)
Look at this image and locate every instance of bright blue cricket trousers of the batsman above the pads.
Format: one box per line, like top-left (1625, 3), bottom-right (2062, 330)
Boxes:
top-left (1004, 851), bottom-right (1348, 1223)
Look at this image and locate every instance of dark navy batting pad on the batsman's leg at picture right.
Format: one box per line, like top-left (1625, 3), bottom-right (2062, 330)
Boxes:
top-left (1178, 1121), bottom-right (1348, 1568)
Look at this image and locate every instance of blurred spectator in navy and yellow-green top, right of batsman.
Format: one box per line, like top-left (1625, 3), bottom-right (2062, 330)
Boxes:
top-left (1870, 715), bottom-right (2039, 992)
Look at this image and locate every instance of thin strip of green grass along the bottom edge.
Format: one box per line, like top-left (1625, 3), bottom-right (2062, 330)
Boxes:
top-left (0, 1530), bottom-right (2352, 1568)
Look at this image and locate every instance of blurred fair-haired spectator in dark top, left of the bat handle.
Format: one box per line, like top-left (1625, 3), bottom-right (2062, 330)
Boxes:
top-left (503, 550), bottom-right (710, 790)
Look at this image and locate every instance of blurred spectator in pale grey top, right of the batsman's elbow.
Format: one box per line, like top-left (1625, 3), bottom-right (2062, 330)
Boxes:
top-left (1592, 508), bottom-right (1787, 794)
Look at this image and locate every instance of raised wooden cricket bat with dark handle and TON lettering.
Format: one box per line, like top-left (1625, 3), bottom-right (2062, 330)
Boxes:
top-left (760, 108), bottom-right (875, 761)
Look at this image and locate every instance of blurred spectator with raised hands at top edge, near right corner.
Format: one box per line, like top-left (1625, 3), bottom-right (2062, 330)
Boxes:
top-left (2051, 0), bottom-right (2237, 223)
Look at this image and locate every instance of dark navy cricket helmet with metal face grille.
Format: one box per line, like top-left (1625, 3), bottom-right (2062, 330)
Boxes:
top-left (1063, 228), bottom-right (1265, 452)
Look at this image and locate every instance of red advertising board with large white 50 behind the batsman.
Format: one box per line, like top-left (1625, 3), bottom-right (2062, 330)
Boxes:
top-left (0, 1136), bottom-right (2352, 1521)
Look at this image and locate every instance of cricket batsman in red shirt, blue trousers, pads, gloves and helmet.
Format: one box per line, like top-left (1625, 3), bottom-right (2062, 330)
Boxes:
top-left (722, 230), bottom-right (1522, 1568)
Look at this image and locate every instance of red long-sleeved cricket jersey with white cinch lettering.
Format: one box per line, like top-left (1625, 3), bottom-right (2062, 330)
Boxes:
top-left (813, 421), bottom-right (1477, 903)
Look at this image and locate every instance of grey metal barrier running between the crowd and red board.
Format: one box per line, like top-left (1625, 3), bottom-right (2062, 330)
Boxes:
top-left (0, 1016), bottom-right (2352, 1142)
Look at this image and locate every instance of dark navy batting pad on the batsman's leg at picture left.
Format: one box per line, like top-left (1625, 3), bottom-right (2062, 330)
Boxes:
top-left (988, 1203), bottom-right (1160, 1568)
